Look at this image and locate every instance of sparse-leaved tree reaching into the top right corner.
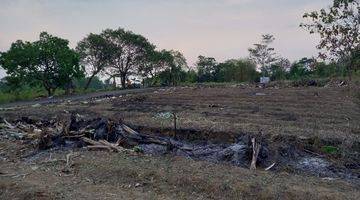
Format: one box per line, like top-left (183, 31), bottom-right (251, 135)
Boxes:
top-left (300, 0), bottom-right (360, 79)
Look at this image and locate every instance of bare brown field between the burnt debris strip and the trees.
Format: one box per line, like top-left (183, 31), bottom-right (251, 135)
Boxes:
top-left (1, 87), bottom-right (360, 140)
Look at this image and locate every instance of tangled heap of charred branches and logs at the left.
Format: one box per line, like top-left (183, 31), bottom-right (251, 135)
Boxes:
top-left (1, 114), bottom-right (183, 152)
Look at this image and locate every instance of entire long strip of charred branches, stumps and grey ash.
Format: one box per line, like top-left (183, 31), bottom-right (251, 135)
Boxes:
top-left (0, 114), bottom-right (359, 181)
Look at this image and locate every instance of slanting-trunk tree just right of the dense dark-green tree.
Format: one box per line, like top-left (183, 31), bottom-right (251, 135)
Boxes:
top-left (76, 33), bottom-right (115, 90)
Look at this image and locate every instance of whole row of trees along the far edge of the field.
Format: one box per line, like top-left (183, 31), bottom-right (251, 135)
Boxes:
top-left (0, 0), bottom-right (360, 101)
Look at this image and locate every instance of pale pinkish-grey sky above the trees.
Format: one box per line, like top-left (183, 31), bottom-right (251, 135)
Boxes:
top-left (0, 0), bottom-right (332, 77)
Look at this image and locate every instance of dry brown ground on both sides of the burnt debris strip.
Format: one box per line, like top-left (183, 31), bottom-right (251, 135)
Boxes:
top-left (0, 86), bottom-right (360, 199)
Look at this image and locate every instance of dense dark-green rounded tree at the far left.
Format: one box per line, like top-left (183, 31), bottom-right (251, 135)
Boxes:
top-left (0, 32), bottom-right (83, 96)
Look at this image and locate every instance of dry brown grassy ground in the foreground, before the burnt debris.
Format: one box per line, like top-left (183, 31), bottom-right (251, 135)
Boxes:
top-left (0, 143), bottom-right (360, 199)
